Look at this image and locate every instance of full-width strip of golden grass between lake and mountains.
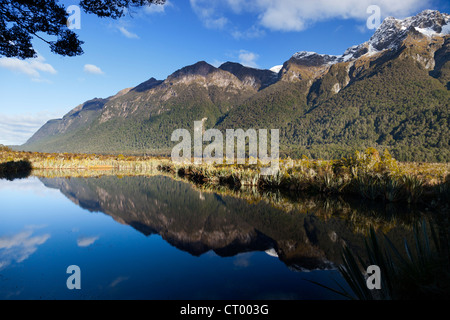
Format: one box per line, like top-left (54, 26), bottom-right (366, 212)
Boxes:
top-left (0, 147), bottom-right (450, 203)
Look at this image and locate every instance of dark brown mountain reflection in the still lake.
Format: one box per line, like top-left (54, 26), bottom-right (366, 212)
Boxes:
top-left (40, 176), bottom-right (422, 269)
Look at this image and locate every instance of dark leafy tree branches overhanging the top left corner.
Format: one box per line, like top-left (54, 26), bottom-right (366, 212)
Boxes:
top-left (0, 0), bottom-right (165, 59)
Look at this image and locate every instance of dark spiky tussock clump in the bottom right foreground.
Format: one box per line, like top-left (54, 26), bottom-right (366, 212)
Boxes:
top-left (315, 221), bottom-right (450, 300)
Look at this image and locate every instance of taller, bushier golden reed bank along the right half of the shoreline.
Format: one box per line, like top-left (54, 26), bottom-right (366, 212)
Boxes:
top-left (159, 148), bottom-right (450, 203)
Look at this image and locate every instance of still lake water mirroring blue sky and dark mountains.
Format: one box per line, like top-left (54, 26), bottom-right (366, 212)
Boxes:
top-left (0, 176), bottom-right (430, 300)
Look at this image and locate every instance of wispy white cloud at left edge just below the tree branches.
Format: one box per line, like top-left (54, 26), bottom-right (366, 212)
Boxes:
top-left (0, 56), bottom-right (57, 82)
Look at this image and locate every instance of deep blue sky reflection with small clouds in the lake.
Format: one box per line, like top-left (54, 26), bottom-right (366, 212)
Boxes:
top-left (0, 178), bottom-right (346, 299)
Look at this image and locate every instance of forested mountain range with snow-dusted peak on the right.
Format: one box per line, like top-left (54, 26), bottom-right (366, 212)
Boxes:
top-left (19, 10), bottom-right (450, 162)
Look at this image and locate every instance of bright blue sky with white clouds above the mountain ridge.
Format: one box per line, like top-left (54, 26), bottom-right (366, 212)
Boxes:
top-left (0, 0), bottom-right (450, 145)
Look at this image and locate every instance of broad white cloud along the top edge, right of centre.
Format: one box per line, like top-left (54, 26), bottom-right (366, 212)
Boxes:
top-left (190, 0), bottom-right (432, 32)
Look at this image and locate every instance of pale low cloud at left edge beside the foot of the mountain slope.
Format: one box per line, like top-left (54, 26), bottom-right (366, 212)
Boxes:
top-left (0, 112), bottom-right (58, 145)
